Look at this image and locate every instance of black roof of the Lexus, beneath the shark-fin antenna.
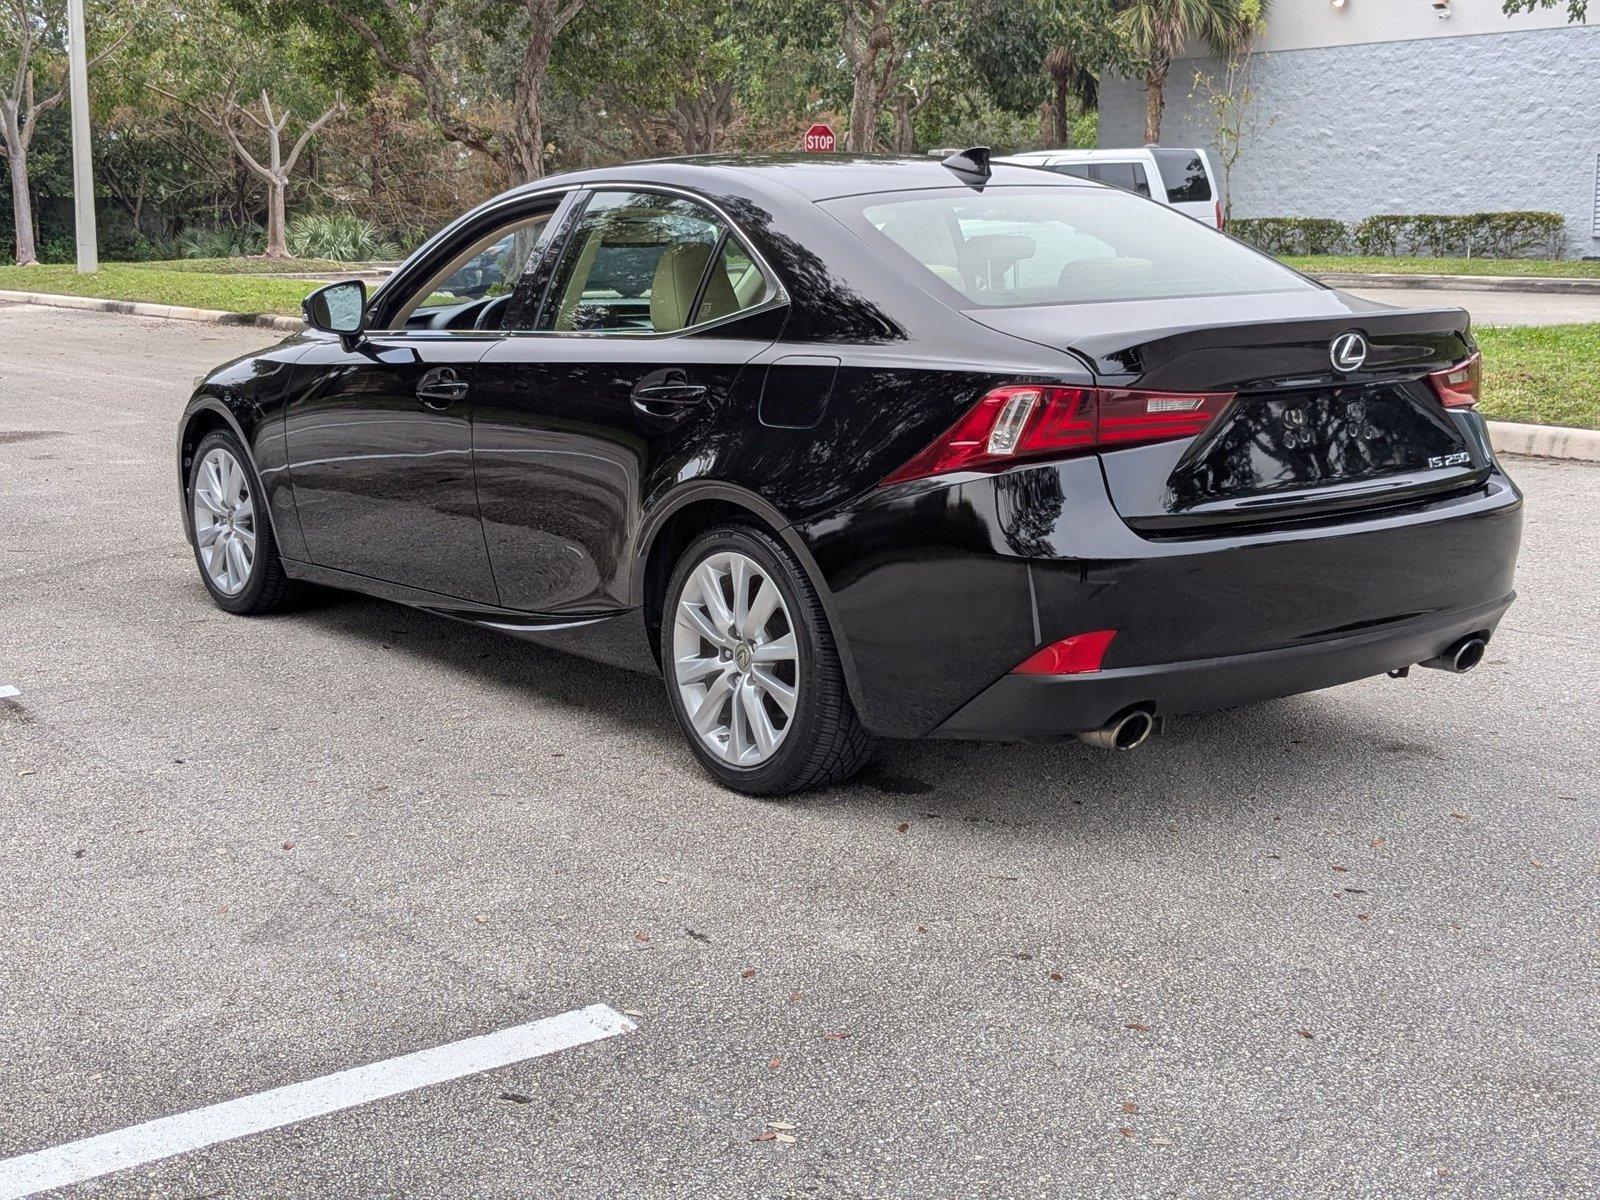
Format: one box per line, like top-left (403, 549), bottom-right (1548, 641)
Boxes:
top-left (505, 154), bottom-right (1099, 202)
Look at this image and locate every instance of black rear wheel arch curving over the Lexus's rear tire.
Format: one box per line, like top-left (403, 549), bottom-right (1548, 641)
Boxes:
top-left (629, 480), bottom-right (861, 706)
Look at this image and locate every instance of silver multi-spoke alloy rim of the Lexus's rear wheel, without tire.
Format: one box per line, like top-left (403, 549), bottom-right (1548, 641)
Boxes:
top-left (672, 550), bottom-right (800, 766)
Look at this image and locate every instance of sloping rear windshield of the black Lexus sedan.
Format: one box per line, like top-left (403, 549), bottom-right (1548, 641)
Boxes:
top-left (824, 186), bottom-right (1317, 309)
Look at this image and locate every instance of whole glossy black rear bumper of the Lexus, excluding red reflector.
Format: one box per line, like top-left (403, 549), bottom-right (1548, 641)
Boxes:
top-left (794, 438), bottom-right (1522, 739)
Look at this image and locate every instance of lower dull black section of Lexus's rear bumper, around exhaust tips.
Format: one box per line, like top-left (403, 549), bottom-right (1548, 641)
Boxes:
top-left (931, 595), bottom-right (1514, 741)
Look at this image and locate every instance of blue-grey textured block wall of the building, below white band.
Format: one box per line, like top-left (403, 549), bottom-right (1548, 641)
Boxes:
top-left (1099, 24), bottom-right (1600, 256)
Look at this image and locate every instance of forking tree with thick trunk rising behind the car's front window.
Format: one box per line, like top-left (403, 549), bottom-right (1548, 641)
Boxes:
top-left (305, 0), bottom-right (587, 182)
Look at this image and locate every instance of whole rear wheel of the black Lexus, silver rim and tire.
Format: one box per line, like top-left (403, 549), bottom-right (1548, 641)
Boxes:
top-left (661, 525), bottom-right (874, 795)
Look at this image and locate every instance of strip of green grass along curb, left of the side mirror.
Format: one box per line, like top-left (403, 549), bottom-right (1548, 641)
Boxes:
top-left (0, 262), bottom-right (328, 317)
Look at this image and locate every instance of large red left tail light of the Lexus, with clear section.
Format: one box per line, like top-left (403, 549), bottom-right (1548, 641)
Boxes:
top-left (883, 384), bottom-right (1234, 483)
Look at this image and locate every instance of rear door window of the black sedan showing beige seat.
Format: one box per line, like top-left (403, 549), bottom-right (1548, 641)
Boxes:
top-left (538, 192), bottom-right (766, 333)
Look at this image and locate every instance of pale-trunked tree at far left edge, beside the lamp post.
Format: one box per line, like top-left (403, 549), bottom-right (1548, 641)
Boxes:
top-left (0, 0), bottom-right (126, 267)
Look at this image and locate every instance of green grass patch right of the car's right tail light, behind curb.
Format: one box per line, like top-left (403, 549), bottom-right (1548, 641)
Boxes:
top-left (1474, 323), bottom-right (1600, 429)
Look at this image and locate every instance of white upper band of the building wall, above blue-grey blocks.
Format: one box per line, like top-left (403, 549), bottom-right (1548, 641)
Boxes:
top-left (1189, 0), bottom-right (1580, 56)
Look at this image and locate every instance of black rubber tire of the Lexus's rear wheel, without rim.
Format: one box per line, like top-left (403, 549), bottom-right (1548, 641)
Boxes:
top-left (661, 525), bottom-right (877, 797)
